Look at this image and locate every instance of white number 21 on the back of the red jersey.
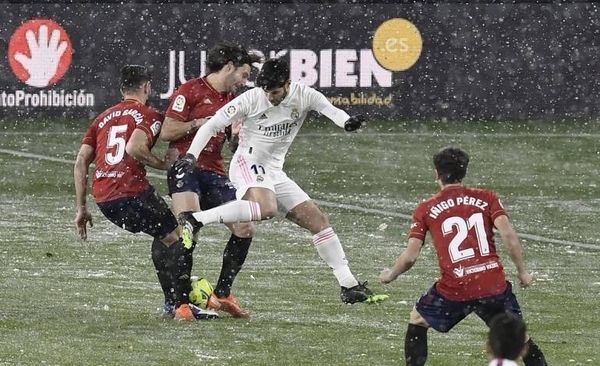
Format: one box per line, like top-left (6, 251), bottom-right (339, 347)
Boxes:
top-left (442, 212), bottom-right (490, 263)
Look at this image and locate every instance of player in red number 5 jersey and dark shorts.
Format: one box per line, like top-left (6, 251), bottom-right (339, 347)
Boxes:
top-left (74, 65), bottom-right (216, 321)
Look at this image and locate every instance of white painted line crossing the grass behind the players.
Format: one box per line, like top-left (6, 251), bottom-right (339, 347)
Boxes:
top-left (0, 149), bottom-right (600, 250)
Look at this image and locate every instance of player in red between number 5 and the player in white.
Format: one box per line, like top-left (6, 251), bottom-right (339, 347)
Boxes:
top-left (161, 43), bottom-right (261, 318)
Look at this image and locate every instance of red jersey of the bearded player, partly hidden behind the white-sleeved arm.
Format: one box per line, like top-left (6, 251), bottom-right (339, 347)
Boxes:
top-left (165, 78), bottom-right (235, 175)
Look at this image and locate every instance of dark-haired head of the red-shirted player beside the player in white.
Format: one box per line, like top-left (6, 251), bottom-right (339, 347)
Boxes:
top-left (206, 42), bottom-right (262, 93)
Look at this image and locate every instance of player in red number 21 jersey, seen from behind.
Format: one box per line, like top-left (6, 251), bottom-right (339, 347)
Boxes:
top-left (380, 147), bottom-right (547, 366)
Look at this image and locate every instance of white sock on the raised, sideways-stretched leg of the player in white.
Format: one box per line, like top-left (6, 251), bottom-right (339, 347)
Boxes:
top-left (193, 200), bottom-right (261, 225)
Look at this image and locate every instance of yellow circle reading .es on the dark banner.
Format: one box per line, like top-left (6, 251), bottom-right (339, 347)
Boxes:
top-left (373, 18), bottom-right (423, 71)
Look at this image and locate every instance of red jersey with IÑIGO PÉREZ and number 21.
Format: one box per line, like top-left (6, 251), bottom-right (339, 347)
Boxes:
top-left (408, 186), bottom-right (506, 301)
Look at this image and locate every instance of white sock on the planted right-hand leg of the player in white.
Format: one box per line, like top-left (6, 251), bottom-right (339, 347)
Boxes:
top-left (313, 227), bottom-right (358, 288)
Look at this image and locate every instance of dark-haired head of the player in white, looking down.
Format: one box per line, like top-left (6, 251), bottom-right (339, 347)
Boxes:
top-left (256, 58), bottom-right (291, 105)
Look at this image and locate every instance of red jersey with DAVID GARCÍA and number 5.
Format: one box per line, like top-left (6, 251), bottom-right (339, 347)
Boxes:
top-left (81, 99), bottom-right (164, 203)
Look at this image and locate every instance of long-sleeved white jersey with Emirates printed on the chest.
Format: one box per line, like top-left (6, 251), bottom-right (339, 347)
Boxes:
top-left (188, 83), bottom-right (350, 169)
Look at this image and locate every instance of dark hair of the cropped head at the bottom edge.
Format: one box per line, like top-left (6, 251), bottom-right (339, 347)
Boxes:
top-left (488, 313), bottom-right (527, 360)
